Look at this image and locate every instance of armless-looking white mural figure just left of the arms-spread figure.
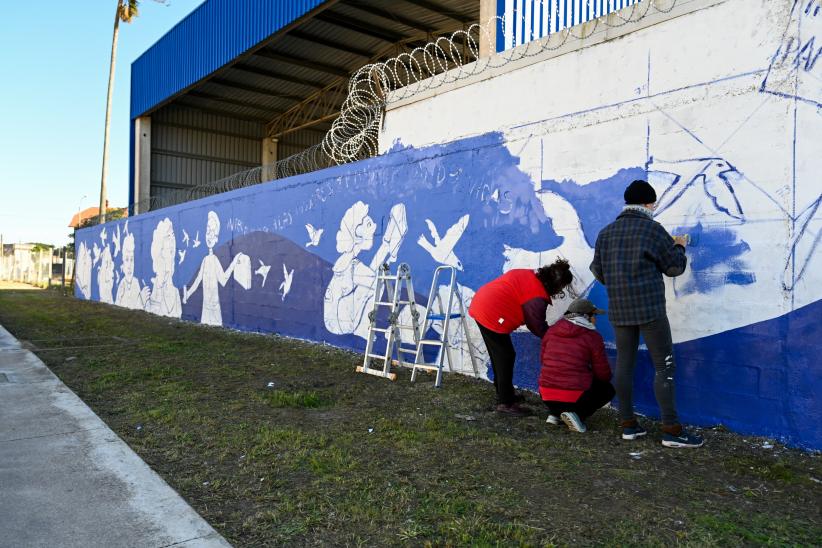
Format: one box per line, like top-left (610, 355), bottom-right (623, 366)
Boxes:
top-left (145, 217), bottom-right (183, 318)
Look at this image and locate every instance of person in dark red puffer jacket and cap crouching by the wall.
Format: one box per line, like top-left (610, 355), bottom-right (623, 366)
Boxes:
top-left (539, 299), bottom-right (615, 432)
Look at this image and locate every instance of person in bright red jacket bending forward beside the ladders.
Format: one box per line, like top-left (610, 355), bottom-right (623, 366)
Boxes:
top-left (468, 259), bottom-right (574, 417)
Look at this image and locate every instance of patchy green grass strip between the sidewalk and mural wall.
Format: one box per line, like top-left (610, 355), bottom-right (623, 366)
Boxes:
top-left (0, 290), bottom-right (822, 546)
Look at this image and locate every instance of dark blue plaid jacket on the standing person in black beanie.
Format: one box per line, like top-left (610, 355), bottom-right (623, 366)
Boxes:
top-left (591, 210), bottom-right (687, 325)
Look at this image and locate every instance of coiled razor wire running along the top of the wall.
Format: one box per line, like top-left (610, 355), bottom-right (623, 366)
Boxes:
top-left (83, 0), bottom-right (681, 224)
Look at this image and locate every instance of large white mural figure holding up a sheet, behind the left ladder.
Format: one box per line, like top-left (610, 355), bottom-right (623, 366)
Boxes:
top-left (323, 201), bottom-right (408, 338)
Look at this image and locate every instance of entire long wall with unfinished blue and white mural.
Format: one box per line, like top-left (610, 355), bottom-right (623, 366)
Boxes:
top-left (77, 0), bottom-right (822, 448)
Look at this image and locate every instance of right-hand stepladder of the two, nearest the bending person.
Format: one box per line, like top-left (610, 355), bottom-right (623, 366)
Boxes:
top-left (411, 266), bottom-right (479, 388)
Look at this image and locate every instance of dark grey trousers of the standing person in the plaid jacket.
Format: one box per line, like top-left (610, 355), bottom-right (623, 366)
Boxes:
top-left (614, 316), bottom-right (677, 425)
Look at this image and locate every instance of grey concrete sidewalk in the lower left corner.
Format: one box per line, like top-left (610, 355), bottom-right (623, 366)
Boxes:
top-left (0, 326), bottom-right (230, 548)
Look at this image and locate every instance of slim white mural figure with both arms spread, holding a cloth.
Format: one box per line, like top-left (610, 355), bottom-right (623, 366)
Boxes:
top-left (183, 211), bottom-right (243, 325)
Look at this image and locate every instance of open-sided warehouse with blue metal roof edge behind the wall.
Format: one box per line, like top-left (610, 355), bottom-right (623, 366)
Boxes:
top-left (129, 0), bottom-right (482, 213)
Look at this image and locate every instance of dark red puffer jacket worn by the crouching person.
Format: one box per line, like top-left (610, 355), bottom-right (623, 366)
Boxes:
top-left (539, 318), bottom-right (611, 402)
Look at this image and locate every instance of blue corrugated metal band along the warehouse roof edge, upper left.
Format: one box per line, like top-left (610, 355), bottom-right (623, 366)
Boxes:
top-left (131, 0), bottom-right (333, 118)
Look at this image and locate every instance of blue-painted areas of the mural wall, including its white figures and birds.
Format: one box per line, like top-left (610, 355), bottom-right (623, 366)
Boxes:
top-left (77, 133), bottom-right (822, 449)
